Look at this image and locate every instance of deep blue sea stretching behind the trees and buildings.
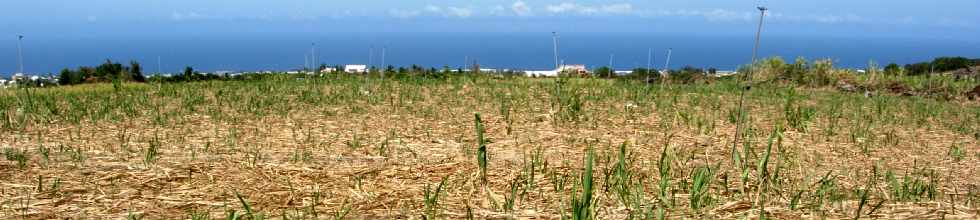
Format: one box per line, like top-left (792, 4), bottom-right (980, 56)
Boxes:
top-left (0, 33), bottom-right (980, 75)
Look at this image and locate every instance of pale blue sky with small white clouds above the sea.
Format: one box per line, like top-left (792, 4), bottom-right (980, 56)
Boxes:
top-left (0, 0), bottom-right (980, 40)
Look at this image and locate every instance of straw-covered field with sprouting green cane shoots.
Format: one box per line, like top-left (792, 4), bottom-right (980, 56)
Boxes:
top-left (0, 75), bottom-right (980, 219)
